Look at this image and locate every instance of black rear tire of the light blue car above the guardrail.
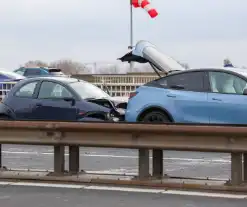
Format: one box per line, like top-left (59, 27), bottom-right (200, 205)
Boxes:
top-left (141, 110), bottom-right (171, 123)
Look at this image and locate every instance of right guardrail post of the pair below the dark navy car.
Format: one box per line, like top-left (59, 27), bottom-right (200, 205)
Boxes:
top-left (69, 146), bottom-right (80, 174)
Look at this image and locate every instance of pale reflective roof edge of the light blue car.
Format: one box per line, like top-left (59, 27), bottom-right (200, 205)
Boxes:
top-left (168, 67), bottom-right (247, 78)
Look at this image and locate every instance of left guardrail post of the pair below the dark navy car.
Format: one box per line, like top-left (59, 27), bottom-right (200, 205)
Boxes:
top-left (54, 145), bottom-right (65, 174)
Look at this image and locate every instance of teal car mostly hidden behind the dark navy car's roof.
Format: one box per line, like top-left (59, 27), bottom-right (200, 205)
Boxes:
top-left (14, 67), bottom-right (66, 77)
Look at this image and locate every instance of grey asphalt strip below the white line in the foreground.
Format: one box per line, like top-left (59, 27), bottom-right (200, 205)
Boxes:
top-left (0, 186), bottom-right (246, 207)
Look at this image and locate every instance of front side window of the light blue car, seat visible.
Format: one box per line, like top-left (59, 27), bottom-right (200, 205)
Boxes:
top-left (209, 72), bottom-right (247, 95)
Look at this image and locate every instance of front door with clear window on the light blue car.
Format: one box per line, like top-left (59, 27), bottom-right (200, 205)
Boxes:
top-left (208, 71), bottom-right (247, 124)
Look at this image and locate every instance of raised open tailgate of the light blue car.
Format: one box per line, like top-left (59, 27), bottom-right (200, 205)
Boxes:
top-left (119, 40), bottom-right (186, 73)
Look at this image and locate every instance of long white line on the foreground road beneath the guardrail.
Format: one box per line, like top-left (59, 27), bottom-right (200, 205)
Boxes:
top-left (0, 182), bottom-right (244, 199)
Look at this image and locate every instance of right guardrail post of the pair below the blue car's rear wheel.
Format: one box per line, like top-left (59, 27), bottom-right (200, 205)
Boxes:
top-left (153, 149), bottom-right (163, 178)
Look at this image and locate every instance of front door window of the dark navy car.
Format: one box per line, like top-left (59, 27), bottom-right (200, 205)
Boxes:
top-left (38, 81), bottom-right (73, 99)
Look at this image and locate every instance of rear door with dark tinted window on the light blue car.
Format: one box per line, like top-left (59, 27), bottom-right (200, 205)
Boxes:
top-left (156, 71), bottom-right (209, 123)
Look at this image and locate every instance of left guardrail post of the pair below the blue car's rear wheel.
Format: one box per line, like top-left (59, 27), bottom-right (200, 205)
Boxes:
top-left (139, 149), bottom-right (149, 179)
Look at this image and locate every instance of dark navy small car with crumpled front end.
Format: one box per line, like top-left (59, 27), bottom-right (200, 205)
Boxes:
top-left (0, 76), bottom-right (125, 121)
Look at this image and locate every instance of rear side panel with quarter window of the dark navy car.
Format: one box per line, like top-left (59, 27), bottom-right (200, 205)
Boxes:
top-left (5, 81), bottom-right (39, 120)
